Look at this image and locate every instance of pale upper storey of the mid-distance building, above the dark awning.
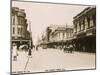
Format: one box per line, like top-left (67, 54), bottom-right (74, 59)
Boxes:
top-left (50, 27), bottom-right (73, 42)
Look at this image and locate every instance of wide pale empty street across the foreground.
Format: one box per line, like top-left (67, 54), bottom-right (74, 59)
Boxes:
top-left (12, 48), bottom-right (95, 72)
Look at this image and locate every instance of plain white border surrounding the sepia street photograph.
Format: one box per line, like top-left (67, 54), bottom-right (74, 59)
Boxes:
top-left (0, 0), bottom-right (100, 75)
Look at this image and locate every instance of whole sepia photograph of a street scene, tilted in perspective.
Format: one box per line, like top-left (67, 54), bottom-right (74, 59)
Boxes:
top-left (11, 1), bottom-right (96, 74)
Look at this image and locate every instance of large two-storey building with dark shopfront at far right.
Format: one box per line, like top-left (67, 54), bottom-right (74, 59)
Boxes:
top-left (73, 6), bottom-right (96, 52)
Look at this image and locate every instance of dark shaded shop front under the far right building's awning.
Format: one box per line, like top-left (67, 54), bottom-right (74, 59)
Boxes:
top-left (75, 29), bottom-right (96, 52)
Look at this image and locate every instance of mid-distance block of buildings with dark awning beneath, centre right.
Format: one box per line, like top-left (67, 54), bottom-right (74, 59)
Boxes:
top-left (40, 25), bottom-right (73, 48)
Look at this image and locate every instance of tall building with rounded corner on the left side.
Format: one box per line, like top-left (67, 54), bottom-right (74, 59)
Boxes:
top-left (12, 7), bottom-right (30, 44)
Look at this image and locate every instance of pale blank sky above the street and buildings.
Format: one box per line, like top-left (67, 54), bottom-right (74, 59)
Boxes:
top-left (12, 1), bottom-right (88, 44)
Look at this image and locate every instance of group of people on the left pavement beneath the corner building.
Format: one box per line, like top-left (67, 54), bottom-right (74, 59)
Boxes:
top-left (12, 43), bottom-right (32, 61)
